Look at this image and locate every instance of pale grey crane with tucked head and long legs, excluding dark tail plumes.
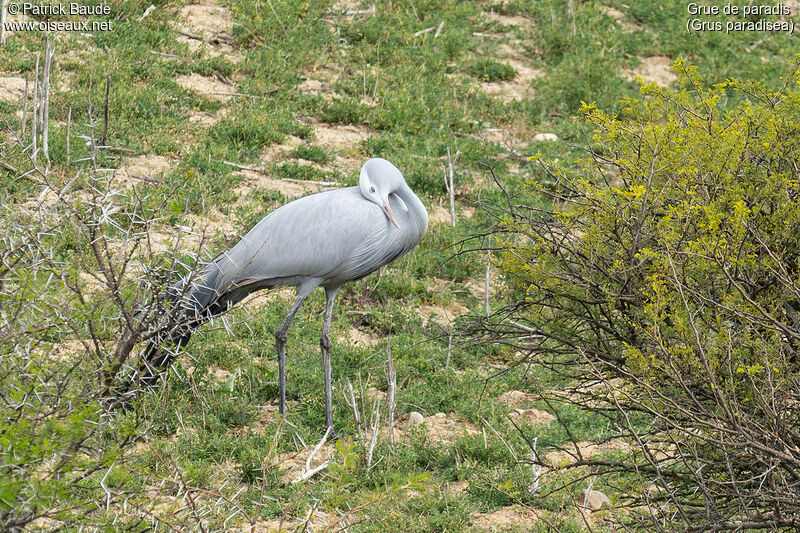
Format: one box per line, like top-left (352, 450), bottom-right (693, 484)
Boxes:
top-left (169, 159), bottom-right (428, 427)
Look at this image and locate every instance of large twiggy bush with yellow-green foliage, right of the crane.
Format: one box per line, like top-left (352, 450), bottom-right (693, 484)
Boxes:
top-left (469, 61), bottom-right (800, 530)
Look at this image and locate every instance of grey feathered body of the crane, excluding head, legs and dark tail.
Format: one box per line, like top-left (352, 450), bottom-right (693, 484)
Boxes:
top-left (191, 183), bottom-right (427, 308)
